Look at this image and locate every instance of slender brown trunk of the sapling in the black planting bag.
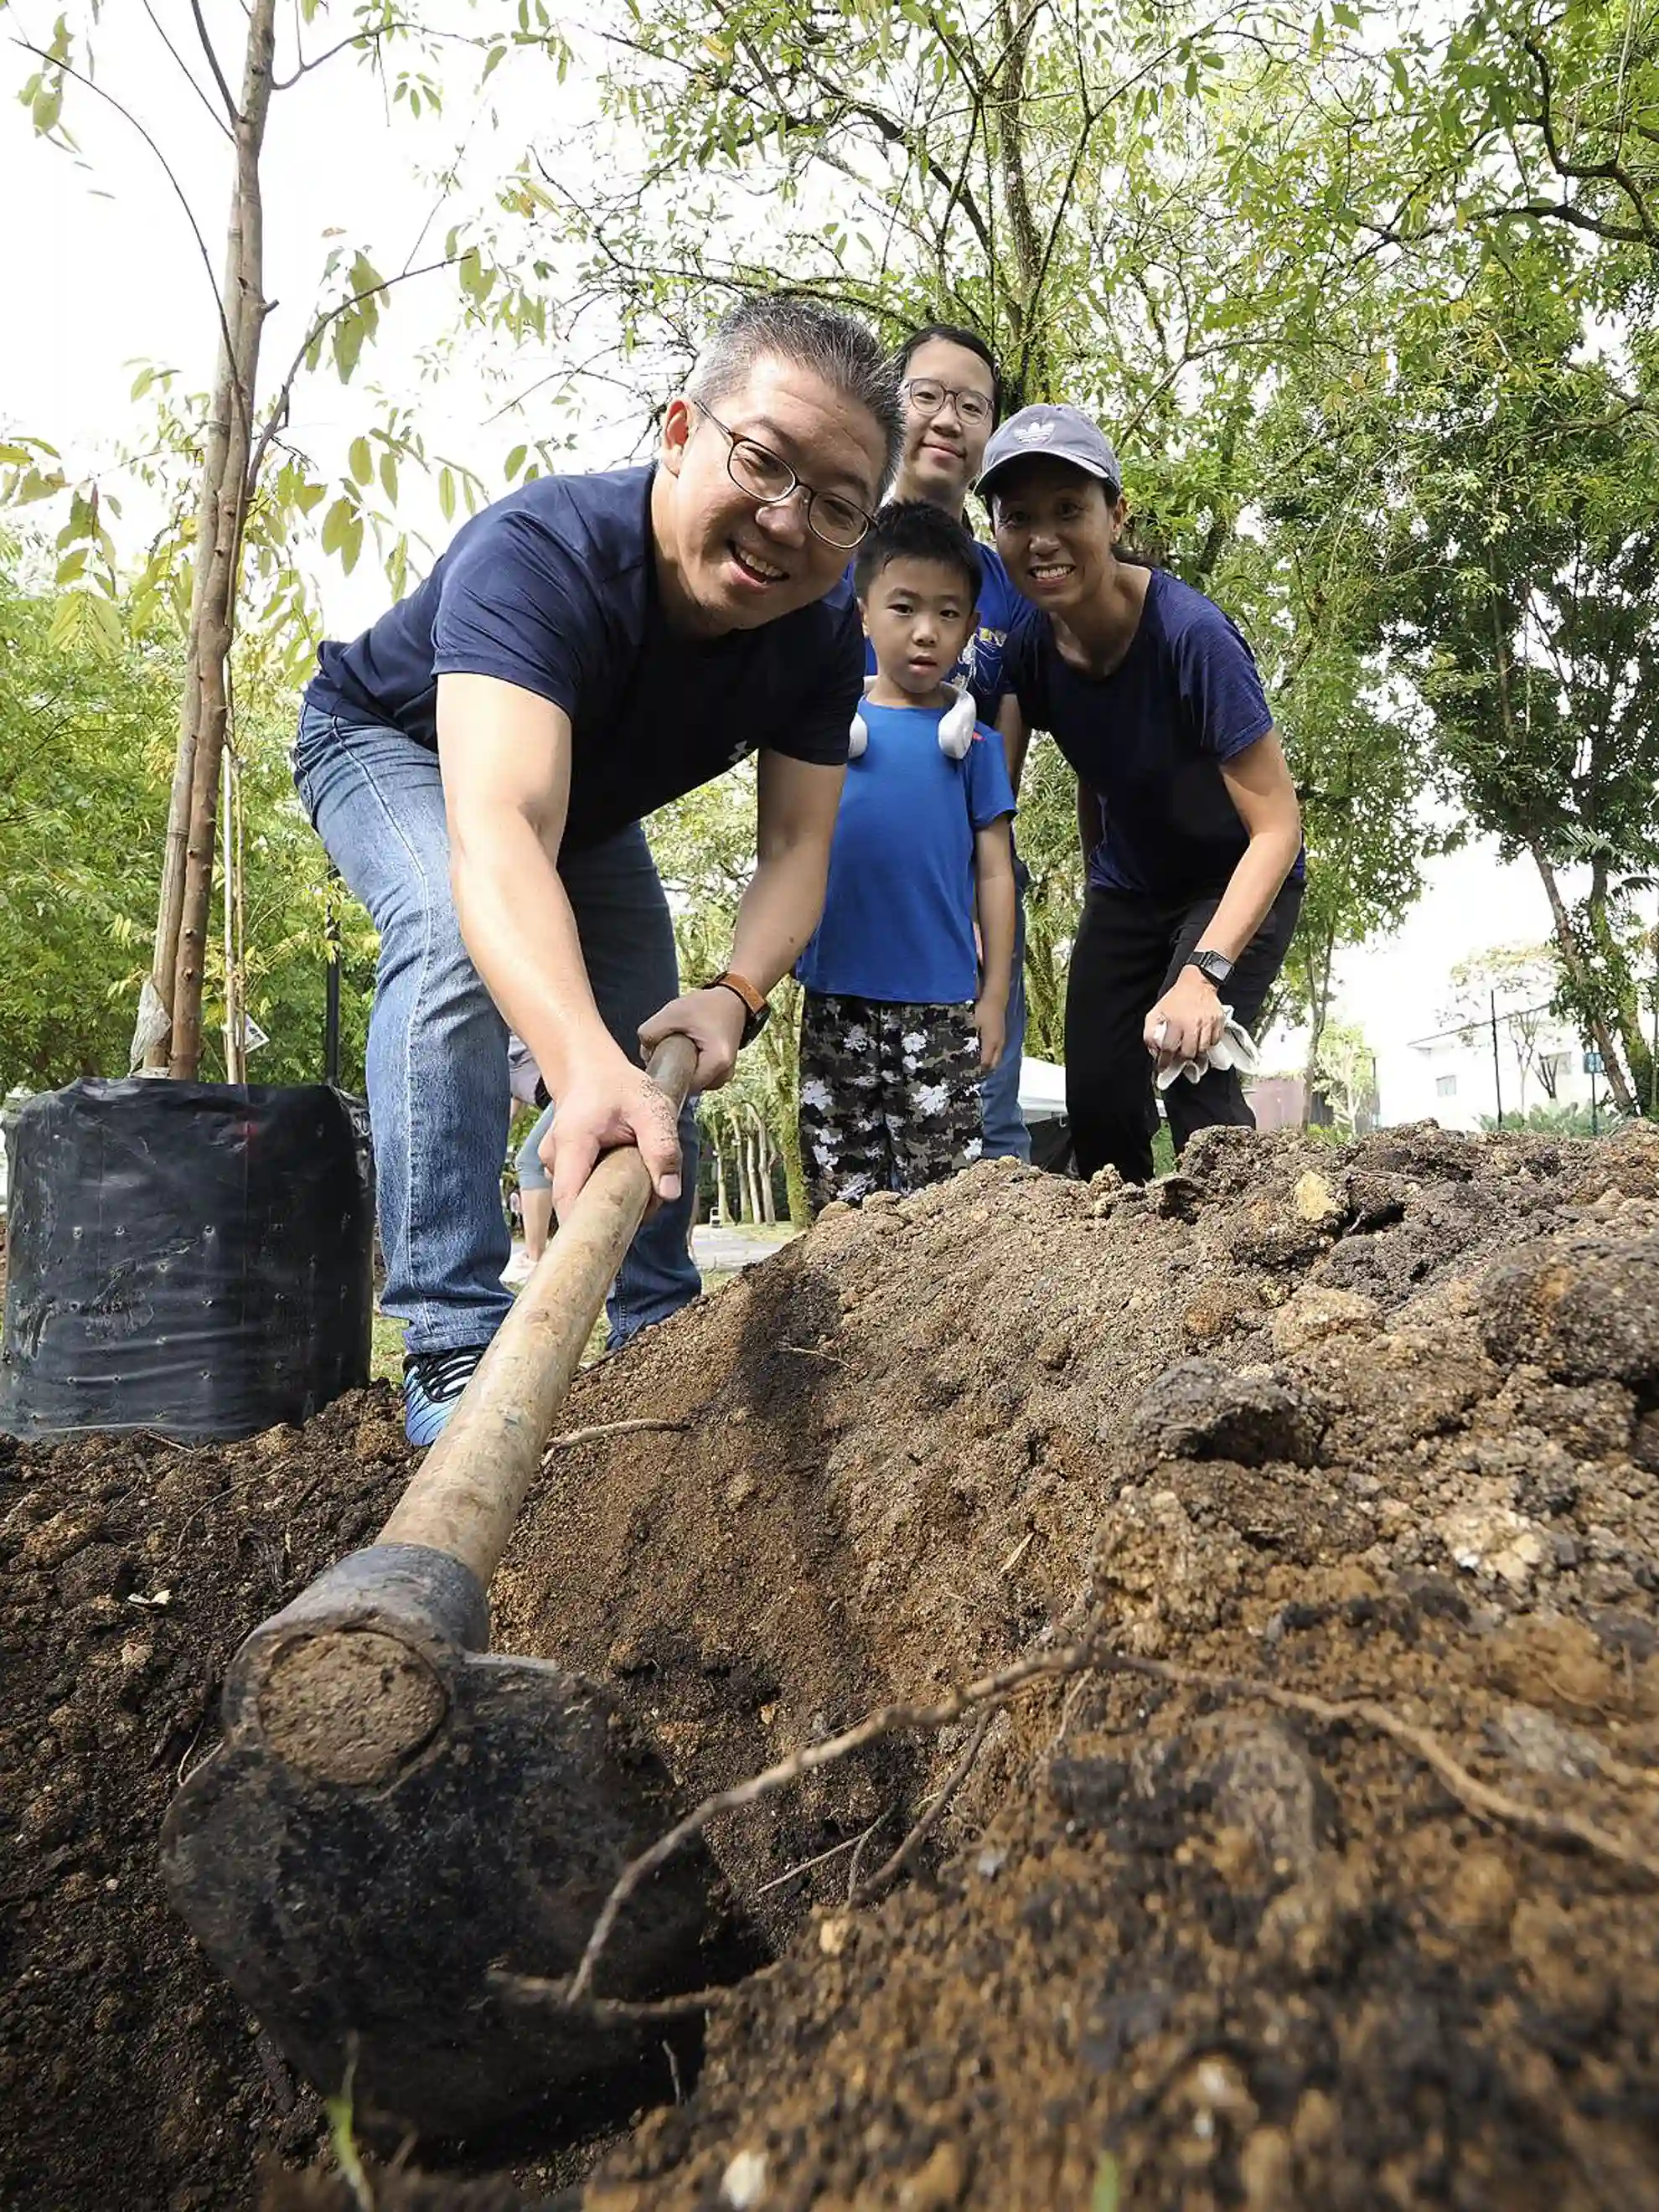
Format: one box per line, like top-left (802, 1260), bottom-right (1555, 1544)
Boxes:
top-left (144, 0), bottom-right (276, 1082)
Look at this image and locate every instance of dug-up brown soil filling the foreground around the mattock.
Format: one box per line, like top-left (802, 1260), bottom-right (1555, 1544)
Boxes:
top-left (0, 1128), bottom-right (1659, 2212)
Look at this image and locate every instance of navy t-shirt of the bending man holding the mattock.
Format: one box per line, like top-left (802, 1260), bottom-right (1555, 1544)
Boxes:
top-left (305, 469), bottom-right (865, 850)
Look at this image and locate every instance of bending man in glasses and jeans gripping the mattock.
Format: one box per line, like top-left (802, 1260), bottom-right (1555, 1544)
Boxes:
top-left (294, 298), bottom-right (900, 1442)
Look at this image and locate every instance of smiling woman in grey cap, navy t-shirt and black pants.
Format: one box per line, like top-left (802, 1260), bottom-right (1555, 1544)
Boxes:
top-left (978, 407), bottom-right (1303, 1183)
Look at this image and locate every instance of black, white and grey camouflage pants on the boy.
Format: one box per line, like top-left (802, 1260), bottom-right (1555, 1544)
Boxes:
top-left (801, 991), bottom-right (985, 1214)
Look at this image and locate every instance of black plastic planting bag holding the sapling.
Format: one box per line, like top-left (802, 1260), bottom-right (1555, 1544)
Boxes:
top-left (0, 1078), bottom-right (374, 1442)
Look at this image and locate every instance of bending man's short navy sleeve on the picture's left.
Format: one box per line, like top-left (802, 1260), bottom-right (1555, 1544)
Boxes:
top-left (432, 513), bottom-right (602, 721)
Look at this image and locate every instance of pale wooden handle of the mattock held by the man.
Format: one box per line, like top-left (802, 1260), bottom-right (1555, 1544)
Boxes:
top-left (378, 1037), bottom-right (697, 1589)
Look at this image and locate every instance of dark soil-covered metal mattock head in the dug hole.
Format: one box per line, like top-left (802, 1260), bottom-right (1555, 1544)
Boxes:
top-left (162, 1544), bottom-right (730, 2135)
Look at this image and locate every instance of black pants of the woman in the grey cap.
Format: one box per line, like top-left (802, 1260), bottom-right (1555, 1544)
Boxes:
top-left (1066, 882), bottom-right (1303, 1183)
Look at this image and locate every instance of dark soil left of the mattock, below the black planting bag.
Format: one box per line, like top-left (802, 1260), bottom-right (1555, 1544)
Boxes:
top-left (0, 1392), bottom-right (422, 2212)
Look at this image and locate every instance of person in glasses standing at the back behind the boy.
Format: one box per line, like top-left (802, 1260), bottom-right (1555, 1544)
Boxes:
top-left (889, 323), bottom-right (1031, 1159)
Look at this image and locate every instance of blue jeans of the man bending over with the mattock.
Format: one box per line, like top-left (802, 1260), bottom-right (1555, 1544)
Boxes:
top-left (294, 705), bottom-right (701, 1351)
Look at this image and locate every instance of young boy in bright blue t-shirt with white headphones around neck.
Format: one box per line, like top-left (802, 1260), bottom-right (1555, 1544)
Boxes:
top-left (796, 500), bottom-right (1013, 1212)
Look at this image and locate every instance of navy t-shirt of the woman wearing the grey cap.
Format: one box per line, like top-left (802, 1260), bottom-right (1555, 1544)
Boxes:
top-left (1002, 568), bottom-right (1305, 898)
